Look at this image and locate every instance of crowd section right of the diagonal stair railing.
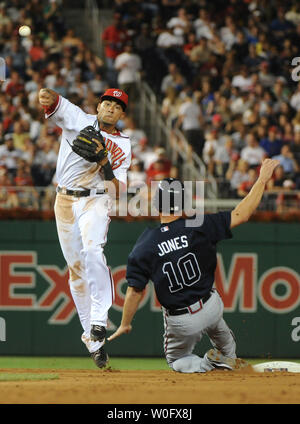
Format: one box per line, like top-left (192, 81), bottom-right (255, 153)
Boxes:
top-left (102, 0), bottom-right (300, 211)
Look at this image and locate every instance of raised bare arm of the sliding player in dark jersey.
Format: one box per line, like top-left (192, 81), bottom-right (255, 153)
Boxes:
top-left (231, 159), bottom-right (279, 228)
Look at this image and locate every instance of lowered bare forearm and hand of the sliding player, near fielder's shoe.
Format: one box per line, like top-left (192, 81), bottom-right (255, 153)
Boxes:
top-left (107, 287), bottom-right (143, 341)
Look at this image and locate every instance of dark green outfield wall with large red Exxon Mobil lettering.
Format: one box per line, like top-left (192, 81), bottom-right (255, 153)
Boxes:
top-left (0, 220), bottom-right (300, 358)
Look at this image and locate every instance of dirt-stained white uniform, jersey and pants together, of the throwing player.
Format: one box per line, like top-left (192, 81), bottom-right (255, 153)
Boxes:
top-left (46, 97), bottom-right (131, 353)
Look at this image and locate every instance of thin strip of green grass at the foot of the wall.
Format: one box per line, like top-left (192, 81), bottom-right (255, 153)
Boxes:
top-left (0, 356), bottom-right (300, 376)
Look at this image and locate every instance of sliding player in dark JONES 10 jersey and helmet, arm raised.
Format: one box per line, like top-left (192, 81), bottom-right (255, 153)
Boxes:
top-left (108, 159), bottom-right (279, 373)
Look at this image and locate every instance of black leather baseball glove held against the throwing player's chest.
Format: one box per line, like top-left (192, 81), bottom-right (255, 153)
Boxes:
top-left (72, 125), bottom-right (108, 162)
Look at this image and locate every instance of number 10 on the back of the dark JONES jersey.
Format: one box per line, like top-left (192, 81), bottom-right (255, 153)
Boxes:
top-left (162, 253), bottom-right (201, 293)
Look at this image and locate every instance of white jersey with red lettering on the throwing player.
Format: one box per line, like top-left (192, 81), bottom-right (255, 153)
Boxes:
top-left (45, 96), bottom-right (131, 190)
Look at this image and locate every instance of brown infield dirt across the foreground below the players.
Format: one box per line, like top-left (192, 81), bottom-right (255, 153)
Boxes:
top-left (0, 369), bottom-right (300, 404)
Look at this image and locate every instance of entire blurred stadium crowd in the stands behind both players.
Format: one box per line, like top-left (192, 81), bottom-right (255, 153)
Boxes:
top-left (0, 0), bottom-right (300, 214)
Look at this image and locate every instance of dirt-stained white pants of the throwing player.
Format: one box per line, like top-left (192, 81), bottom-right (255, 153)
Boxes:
top-left (54, 193), bottom-right (114, 352)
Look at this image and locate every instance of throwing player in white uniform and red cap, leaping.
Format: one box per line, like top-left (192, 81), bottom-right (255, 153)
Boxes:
top-left (39, 88), bottom-right (131, 368)
